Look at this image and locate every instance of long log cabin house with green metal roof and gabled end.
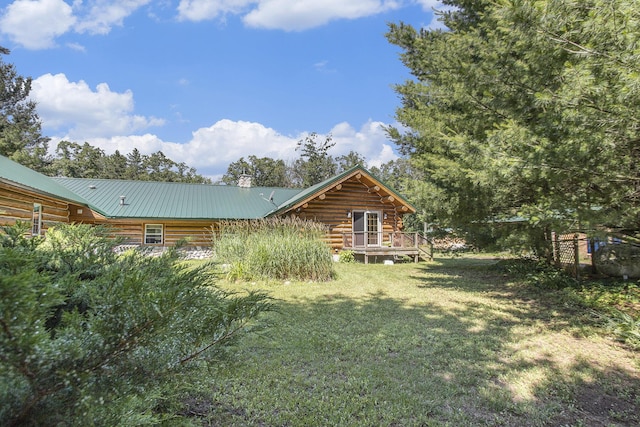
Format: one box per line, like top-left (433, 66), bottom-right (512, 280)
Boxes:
top-left (0, 156), bottom-right (424, 262)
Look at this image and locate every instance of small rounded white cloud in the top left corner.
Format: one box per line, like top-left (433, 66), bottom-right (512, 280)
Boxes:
top-left (0, 0), bottom-right (76, 49)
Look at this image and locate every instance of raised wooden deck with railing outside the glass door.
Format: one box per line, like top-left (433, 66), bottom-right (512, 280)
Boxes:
top-left (342, 232), bottom-right (433, 264)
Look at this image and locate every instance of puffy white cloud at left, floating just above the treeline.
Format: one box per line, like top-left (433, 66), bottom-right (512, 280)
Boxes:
top-left (31, 74), bottom-right (164, 141)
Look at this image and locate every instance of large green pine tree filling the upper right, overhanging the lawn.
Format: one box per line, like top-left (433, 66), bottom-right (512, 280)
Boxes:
top-left (387, 0), bottom-right (640, 241)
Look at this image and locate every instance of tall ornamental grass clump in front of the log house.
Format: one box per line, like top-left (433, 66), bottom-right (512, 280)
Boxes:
top-left (213, 218), bottom-right (334, 281)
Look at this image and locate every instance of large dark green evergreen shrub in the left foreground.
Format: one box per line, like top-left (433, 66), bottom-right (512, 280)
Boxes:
top-left (0, 225), bottom-right (270, 425)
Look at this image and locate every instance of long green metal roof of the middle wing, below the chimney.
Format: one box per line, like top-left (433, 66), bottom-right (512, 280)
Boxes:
top-left (53, 178), bottom-right (301, 219)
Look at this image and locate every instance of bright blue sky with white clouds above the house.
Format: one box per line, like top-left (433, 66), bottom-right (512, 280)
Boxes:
top-left (0, 0), bottom-right (442, 179)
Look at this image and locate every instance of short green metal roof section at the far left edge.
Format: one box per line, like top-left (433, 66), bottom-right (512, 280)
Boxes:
top-left (0, 156), bottom-right (88, 205)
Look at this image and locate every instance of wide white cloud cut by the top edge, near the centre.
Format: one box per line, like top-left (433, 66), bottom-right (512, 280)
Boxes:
top-left (243, 0), bottom-right (400, 31)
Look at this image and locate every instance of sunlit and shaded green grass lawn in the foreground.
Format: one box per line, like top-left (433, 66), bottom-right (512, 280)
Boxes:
top-left (185, 258), bottom-right (640, 426)
